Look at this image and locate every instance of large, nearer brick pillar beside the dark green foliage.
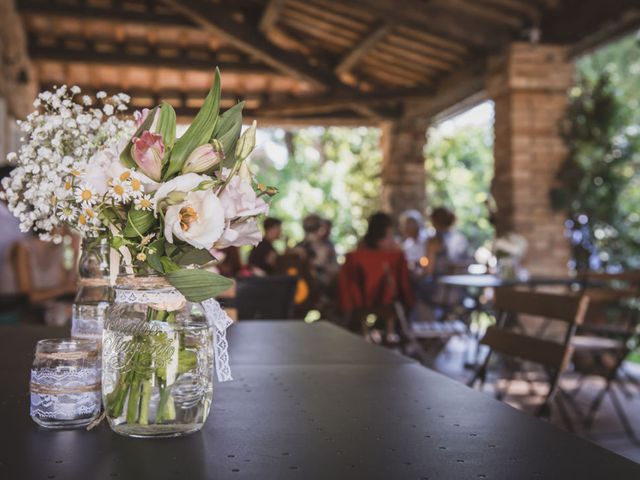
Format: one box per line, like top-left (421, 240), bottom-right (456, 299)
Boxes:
top-left (487, 43), bottom-right (573, 275)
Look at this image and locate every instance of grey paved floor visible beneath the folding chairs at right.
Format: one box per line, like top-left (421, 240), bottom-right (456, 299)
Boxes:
top-left (434, 339), bottom-right (640, 463)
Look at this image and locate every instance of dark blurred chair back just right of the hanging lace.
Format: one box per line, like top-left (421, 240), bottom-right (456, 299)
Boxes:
top-left (228, 275), bottom-right (297, 320)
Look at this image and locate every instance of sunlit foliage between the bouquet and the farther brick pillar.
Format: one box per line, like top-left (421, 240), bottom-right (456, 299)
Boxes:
top-left (251, 127), bottom-right (382, 253)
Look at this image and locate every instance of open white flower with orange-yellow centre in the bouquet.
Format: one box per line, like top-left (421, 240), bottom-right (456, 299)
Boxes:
top-left (166, 190), bottom-right (225, 249)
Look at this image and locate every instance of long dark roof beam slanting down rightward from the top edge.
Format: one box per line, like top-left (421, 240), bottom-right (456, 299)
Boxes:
top-left (161, 0), bottom-right (336, 89)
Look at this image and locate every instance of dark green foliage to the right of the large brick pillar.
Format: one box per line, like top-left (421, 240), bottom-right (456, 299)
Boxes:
top-left (551, 32), bottom-right (640, 270)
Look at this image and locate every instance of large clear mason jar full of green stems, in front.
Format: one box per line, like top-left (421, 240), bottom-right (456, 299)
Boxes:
top-left (102, 275), bottom-right (214, 437)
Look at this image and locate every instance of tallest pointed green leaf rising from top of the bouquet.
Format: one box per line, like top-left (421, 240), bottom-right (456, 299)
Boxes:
top-left (163, 68), bottom-right (220, 180)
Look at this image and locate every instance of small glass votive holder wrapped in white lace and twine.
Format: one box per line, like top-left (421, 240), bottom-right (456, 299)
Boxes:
top-left (30, 338), bottom-right (102, 429)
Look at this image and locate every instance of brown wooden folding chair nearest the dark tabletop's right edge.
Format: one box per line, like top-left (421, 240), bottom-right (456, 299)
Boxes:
top-left (468, 288), bottom-right (589, 431)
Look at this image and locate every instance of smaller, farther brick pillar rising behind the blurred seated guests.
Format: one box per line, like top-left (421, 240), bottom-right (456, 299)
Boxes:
top-left (380, 118), bottom-right (429, 218)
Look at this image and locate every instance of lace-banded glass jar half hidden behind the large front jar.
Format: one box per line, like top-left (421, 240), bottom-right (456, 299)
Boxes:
top-left (71, 238), bottom-right (111, 343)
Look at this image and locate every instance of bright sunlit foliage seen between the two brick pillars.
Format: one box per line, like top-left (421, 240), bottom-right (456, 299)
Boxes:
top-left (426, 125), bottom-right (494, 248)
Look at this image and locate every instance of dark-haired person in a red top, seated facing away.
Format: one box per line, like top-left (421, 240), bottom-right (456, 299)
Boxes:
top-left (338, 213), bottom-right (414, 341)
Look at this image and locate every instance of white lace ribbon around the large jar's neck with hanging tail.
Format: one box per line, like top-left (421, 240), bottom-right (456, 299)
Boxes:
top-left (115, 287), bottom-right (233, 382)
